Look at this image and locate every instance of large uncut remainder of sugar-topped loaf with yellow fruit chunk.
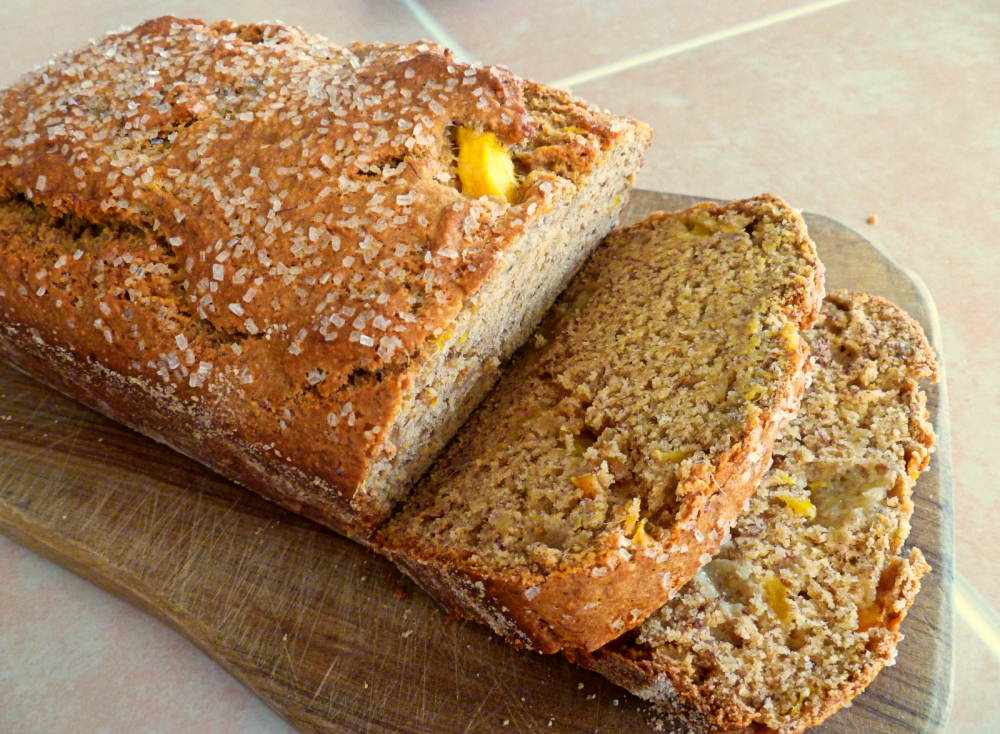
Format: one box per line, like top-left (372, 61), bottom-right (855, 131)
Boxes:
top-left (0, 18), bottom-right (649, 540)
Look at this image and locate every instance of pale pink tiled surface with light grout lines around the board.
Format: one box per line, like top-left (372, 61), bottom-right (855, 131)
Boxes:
top-left (0, 0), bottom-right (1000, 734)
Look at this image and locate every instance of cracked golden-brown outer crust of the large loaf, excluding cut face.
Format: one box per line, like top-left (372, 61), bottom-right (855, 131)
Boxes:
top-left (0, 17), bottom-right (636, 528)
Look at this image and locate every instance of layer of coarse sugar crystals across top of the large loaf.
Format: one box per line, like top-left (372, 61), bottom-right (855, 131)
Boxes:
top-left (0, 18), bottom-right (620, 408)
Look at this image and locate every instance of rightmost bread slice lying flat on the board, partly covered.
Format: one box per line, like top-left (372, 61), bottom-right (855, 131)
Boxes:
top-left (585, 292), bottom-right (937, 734)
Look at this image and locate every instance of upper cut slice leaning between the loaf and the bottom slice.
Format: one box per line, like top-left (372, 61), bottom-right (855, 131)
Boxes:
top-left (375, 196), bottom-right (823, 652)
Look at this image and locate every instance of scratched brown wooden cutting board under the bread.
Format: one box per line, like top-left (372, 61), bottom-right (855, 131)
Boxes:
top-left (0, 191), bottom-right (952, 734)
